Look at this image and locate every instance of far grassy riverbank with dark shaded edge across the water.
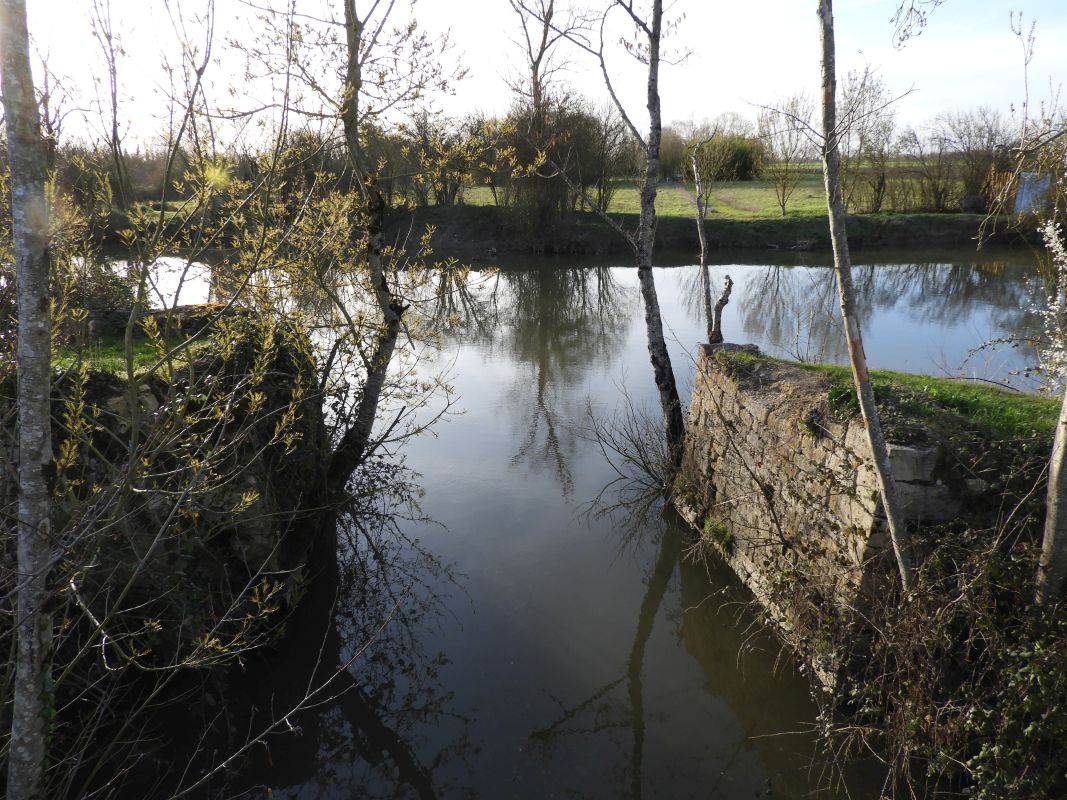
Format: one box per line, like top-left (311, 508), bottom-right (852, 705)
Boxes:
top-left (98, 175), bottom-right (1023, 260)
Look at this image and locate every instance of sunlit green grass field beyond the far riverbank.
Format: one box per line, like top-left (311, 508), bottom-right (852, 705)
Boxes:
top-left (463, 174), bottom-right (826, 220)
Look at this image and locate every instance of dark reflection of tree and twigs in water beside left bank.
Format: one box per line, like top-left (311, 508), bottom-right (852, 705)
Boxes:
top-left (231, 462), bottom-right (472, 800)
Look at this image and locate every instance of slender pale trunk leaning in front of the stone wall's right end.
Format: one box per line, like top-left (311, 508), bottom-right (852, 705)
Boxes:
top-left (818, 0), bottom-right (912, 591)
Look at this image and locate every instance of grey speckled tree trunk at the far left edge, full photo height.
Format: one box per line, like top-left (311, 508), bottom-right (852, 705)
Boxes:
top-left (0, 0), bottom-right (54, 800)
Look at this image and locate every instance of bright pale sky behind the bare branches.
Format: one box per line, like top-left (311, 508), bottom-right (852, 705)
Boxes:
top-left (28, 0), bottom-right (1067, 146)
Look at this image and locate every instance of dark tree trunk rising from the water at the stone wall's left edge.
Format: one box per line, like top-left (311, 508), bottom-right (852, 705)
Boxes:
top-left (637, 0), bottom-right (685, 468)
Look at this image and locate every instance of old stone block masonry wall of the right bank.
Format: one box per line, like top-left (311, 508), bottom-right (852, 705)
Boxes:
top-left (675, 345), bottom-right (962, 679)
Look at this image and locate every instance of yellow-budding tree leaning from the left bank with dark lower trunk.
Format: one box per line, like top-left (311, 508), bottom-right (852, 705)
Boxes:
top-left (245, 0), bottom-right (461, 497)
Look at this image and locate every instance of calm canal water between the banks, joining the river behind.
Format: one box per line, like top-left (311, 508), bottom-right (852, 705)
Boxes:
top-left (242, 254), bottom-right (1041, 799)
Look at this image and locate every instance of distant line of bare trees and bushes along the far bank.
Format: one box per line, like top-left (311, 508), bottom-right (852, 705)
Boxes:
top-left (14, 90), bottom-right (1040, 246)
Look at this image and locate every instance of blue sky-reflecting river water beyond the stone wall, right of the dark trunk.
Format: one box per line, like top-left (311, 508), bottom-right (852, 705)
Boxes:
top-left (682, 260), bottom-right (1042, 389)
